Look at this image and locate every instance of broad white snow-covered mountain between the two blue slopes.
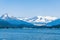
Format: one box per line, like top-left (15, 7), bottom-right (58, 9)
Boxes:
top-left (26, 16), bottom-right (58, 26)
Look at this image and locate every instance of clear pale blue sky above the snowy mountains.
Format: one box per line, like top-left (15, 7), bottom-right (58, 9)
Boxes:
top-left (0, 0), bottom-right (60, 17)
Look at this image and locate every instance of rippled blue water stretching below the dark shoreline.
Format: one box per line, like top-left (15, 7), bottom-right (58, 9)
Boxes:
top-left (0, 28), bottom-right (60, 40)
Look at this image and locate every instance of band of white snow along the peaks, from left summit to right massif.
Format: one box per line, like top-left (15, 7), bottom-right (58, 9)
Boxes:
top-left (1, 13), bottom-right (58, 23)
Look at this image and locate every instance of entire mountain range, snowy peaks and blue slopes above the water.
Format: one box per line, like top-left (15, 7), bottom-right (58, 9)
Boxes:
top-left (0, 14), bottom-right (60, 27)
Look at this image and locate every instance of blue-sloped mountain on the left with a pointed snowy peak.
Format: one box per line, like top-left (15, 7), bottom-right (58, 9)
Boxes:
top-left (0, 14), bottom-right (33, 26)
